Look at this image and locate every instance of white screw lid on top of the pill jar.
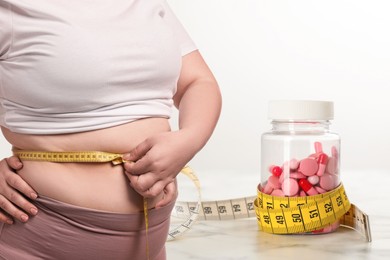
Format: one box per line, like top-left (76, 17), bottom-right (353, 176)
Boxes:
top-left (268, 100), bottom-right (333, 120)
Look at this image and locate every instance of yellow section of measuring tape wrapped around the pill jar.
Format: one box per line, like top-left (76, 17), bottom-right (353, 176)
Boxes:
top-left (255, 185), bottom-right (351, 234)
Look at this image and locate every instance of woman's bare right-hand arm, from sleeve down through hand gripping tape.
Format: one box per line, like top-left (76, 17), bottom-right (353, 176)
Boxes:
top-left (124, 51), bottom-right (222, 203)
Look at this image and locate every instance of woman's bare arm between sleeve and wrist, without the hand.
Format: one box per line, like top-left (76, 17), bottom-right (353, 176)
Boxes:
top-left (174, 51), bottom-right (222, 154)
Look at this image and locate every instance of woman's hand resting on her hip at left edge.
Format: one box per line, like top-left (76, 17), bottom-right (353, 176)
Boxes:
top-left (0, 156), bottom-right (38, 224)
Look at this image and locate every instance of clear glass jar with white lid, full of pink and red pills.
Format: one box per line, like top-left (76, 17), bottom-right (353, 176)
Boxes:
top-left (259, 100), bottom-right (340, 233)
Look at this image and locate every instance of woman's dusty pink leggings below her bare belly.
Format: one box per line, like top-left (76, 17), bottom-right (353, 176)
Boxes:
top-left (0, 197), bottom-right (174, 260)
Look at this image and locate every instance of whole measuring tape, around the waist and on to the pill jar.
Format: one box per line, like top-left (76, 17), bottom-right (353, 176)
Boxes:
top-left (13, 150), bottom-right (371, 241)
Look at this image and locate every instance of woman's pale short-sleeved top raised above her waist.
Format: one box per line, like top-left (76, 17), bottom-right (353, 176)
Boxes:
top-left (0, 0), bottom-right (196, 134)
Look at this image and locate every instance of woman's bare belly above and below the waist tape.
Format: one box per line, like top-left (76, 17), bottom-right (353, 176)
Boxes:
top-left (2, 118), bottom-right (170, 213)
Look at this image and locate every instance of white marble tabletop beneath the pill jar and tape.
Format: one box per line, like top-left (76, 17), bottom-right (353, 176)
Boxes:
top-left (167, 170), bottom-right (390, 260)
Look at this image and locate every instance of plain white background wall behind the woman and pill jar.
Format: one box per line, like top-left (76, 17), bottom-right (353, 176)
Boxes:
top-left (0, 0), bottom-right (390, 195)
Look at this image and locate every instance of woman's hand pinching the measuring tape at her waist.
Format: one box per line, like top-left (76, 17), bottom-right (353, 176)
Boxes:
top-left (123, 131), bottom-right (195, 201)
